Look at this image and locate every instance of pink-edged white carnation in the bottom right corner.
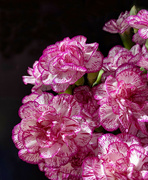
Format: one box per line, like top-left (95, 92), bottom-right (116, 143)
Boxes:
top-left (82, 134), bottom-right (148, 180)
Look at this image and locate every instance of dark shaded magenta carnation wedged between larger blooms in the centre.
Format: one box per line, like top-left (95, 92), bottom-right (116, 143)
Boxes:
top-left (73, 86), bottom-right (100, 130)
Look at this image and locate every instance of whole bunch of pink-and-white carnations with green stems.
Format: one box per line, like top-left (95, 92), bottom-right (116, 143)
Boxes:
top-left (12, 7), bottom-right (148, 180)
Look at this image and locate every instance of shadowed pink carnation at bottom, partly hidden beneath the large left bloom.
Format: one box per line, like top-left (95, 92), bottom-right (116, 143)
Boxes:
top-left (39, 133), bottom-right (102, 180)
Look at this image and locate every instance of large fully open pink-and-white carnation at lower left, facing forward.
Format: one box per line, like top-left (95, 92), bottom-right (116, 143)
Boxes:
top-left (12, 93), bottom-right (91, 167)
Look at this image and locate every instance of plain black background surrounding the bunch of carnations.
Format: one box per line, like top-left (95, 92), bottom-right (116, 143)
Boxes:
top-left (0, 0), bottom-right (148, 180)
